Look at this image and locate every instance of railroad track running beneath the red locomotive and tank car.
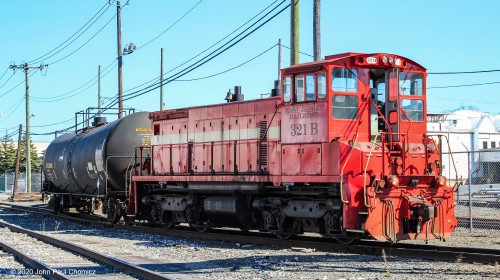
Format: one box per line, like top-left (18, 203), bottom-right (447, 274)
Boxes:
top-left (0, 203), bottom-right (500, 264)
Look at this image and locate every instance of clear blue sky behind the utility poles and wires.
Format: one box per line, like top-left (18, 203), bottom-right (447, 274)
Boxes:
top-left (0, 0), bottom-right (500, 141)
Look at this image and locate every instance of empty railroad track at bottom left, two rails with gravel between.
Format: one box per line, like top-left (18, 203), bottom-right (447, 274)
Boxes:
top-left (0, 208), bottom-right (172, 279)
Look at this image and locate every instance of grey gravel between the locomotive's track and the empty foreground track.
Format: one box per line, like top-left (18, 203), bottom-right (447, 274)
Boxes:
top-left (0, 207), bottom-right (500, 280)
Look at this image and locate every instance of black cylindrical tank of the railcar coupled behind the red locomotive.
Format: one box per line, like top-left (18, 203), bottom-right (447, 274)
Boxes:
top-left (43, 112), bottom-right (151, 195)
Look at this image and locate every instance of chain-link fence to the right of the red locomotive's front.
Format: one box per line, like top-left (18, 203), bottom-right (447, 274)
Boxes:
top-left (442, 150), bottom-right (500, 232)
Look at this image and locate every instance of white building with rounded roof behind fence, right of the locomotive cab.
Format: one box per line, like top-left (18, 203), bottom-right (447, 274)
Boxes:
top-left (427, 107), bottom-right (500, 183)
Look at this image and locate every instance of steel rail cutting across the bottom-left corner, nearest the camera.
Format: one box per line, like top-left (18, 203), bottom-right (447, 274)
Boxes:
top-left (0, 238), bottom-right (70, 280)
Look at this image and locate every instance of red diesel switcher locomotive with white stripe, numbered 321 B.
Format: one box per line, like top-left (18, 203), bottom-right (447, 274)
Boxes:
top-left (127, 53), bottom-right (457, 242)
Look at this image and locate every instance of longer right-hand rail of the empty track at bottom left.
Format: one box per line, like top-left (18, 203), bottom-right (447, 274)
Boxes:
top-left (0, 217), bottom-right (174, 279)
